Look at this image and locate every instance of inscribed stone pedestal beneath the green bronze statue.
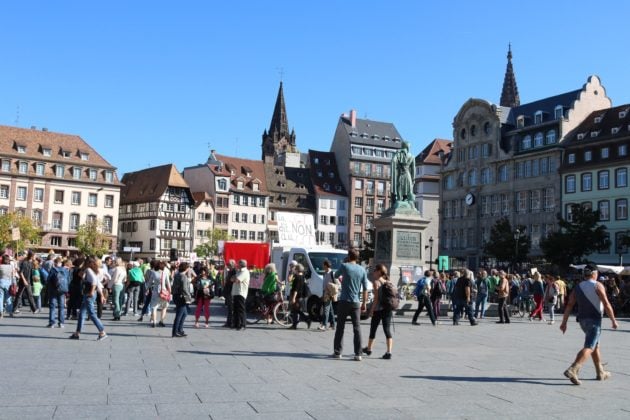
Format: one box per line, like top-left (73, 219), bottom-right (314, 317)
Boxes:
top-left (374, 201), bottom-right (429, 287)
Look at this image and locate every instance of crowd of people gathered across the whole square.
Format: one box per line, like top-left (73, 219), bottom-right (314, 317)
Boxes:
top-left (0, 249), bottom-right (630, 384)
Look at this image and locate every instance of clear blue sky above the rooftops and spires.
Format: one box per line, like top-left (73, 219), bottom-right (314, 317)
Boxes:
top-left (0, 0), bottom-right (630, 177)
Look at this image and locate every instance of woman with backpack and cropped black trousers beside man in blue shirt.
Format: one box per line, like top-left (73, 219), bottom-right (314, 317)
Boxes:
top-left (363, 264), bottom-right (398, 360)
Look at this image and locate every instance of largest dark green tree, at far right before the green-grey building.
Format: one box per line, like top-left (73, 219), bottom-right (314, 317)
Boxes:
top-left (540, 204), bottom-right (610, 268)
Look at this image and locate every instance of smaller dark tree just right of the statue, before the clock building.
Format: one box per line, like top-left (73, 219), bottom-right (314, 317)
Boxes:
top-left (483, 217), bottom-right (531, 264)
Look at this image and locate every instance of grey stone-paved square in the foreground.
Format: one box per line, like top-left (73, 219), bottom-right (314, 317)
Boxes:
top-left (0, 301), bottom-right (630, 420)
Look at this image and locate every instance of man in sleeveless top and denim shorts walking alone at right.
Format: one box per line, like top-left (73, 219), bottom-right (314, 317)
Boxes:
top-left (560, 267), bottom-right (617, 385)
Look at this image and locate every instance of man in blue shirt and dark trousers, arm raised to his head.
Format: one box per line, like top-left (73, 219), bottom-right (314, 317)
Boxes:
top-left (332, 249), bottom-right (368, 361)
